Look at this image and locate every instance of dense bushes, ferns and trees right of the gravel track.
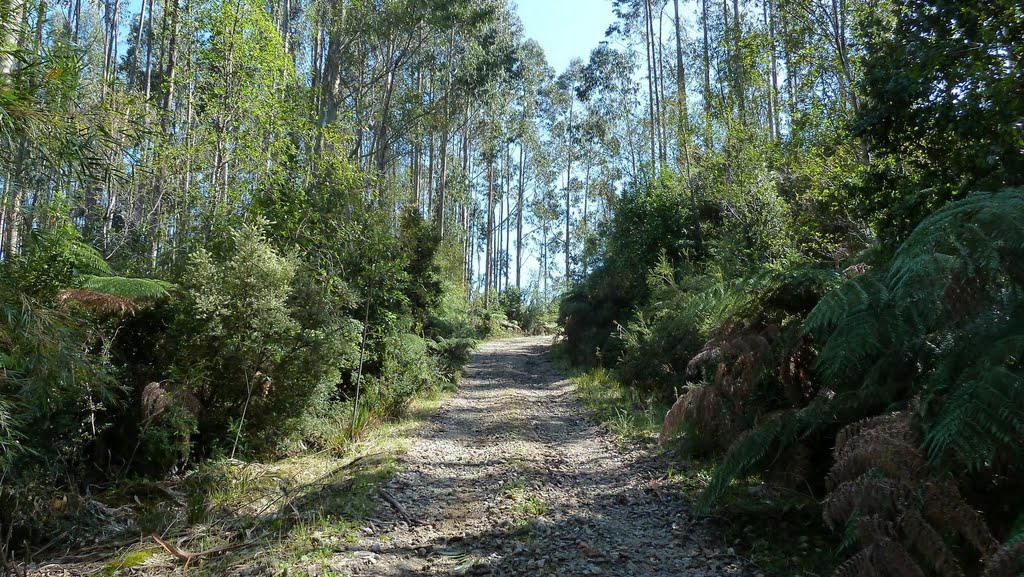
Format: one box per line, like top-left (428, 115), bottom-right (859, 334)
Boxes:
top-left (560, 1), bottom-right (1024, 576)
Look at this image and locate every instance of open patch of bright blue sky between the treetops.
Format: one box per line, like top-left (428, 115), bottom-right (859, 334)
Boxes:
top-left (516, 0), bottom-right (614, 72)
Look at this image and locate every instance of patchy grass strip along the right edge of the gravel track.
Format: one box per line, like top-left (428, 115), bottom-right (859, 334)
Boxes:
top-left (557, 368), bottom-right (840, 575)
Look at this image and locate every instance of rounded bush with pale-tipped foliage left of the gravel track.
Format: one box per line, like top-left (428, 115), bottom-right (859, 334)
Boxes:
top-left (172, 228), bottom-right (358, 453)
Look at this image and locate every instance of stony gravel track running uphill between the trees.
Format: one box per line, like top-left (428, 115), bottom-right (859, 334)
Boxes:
top-left (332, 337), bottom-right (750, 577)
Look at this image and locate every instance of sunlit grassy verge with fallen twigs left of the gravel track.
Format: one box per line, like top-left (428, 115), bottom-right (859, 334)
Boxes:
top-left (26, 371), bottom-right (454, 577)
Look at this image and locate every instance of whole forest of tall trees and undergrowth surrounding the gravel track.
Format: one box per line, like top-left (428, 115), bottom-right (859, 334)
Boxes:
top-left (0, 0), bottom-right (1024, 577)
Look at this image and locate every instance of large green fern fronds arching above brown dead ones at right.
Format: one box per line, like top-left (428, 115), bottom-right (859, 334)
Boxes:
top-left (706, 189), bottom-right (1024, 573)
